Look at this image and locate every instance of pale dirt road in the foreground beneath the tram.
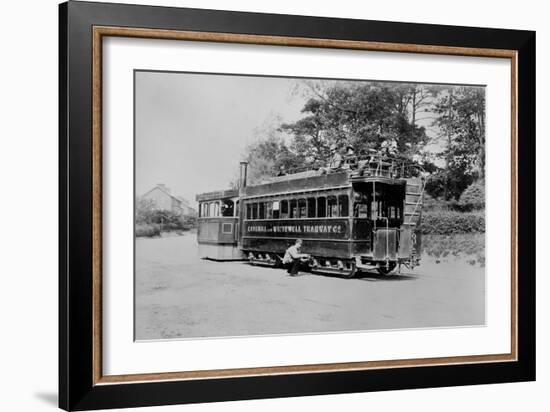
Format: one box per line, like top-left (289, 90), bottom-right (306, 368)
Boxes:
top-left (136, 234), bottom-right (485, 340)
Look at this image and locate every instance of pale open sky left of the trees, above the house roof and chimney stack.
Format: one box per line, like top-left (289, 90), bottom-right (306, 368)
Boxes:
top-left (135, 71), bottom-right (305, 205)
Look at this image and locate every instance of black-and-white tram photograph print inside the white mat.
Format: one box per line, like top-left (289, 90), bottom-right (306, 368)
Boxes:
top-left (134, 69), bottom-right (486, 341)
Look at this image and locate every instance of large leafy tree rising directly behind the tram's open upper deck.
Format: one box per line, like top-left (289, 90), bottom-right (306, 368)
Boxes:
top-left (281, 82), bottom-right (434, 163)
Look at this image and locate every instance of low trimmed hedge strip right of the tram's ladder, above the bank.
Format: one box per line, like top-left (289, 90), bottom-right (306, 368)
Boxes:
top-left (420, 210), bottom-right (485, 235)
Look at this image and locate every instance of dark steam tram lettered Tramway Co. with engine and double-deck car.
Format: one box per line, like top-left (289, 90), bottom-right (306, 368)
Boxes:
top-left (197, 155), bottom-right (424, 277)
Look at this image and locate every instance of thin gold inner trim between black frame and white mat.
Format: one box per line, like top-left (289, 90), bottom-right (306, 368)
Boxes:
top-left (92, 26), bottom-right (518, 385)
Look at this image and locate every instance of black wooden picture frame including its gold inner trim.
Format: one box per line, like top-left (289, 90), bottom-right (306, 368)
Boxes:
top-left (59, 1), bottom-right (535, 410)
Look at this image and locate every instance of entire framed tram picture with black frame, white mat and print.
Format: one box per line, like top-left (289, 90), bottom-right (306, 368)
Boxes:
top-left (59, 1), bottom-right (535, 410)
